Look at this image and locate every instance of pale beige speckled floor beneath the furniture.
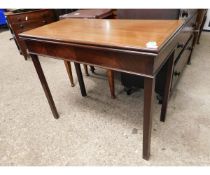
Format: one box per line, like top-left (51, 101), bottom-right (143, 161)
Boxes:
top-left (0, 31), bottom-right (210, 166)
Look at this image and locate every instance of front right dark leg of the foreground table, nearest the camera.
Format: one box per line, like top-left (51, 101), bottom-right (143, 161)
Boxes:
top-left (143, 77), bottom-right (155, 160)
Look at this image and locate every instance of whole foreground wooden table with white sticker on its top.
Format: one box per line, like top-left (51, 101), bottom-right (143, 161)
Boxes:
top-left (20, 19), bottom-right (183, 160)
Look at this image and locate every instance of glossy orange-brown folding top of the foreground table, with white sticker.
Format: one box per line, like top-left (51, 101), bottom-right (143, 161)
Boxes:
top-left (20, 19), bottom-right (183, 53)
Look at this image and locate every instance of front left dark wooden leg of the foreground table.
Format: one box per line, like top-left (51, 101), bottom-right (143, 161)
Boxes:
top-left (30, 54), bottom-right (59, 119)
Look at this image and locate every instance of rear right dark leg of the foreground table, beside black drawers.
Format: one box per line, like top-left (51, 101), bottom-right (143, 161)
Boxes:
top-left (160, 53), bottom-right (174, 122)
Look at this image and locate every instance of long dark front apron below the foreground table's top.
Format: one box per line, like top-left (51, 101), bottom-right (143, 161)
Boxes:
top-left (25, 40), bottom-right (156, 77)
